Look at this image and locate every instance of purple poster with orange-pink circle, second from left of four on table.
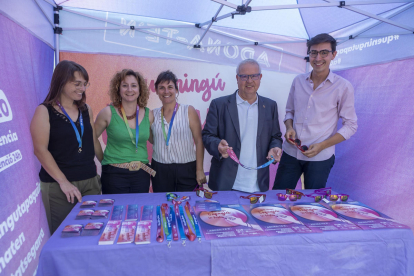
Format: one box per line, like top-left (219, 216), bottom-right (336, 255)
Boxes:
top-left (250, 204), bottom-right (320, 236)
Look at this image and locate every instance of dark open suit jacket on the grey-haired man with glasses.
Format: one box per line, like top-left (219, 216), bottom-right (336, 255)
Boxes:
top-left (202, 90), bottom-right (282, 192)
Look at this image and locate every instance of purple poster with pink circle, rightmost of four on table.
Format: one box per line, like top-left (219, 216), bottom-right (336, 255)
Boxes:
top-left (324, 201), bottom-right (410, 230)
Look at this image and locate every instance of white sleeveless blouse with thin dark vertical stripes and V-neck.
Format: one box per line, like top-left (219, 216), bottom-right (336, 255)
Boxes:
top-left (151, 104), bottom-right (196, 164)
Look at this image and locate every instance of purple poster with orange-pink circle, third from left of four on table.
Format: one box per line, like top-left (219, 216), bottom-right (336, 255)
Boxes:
top-left (283, 203), bottom-right (361, 231)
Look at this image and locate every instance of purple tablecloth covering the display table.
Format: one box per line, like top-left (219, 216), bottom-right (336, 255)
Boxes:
top-left (37, 191), bottom-right (414, 276)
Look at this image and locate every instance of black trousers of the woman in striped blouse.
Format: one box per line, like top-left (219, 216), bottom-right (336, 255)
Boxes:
top-left (151, 159), bottom-right (197, 193)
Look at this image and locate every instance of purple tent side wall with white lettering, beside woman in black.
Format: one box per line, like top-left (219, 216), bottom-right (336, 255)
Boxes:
top-left (0, 14), bottom-right (53, 275)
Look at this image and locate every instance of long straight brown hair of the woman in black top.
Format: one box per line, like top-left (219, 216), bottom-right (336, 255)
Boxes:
top-left (43, 60), bottom-right (89, 111)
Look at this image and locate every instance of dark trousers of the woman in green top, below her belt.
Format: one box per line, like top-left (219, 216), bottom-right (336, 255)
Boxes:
top-left (101, 164), bottom-right (150, 194)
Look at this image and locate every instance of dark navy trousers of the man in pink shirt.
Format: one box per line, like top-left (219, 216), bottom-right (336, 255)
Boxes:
top-left (273, 153), bottom-right (335, 190)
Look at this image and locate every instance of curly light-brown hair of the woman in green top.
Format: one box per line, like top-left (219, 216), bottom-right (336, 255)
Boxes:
top-left (109, 69), bottom-right (149, 107)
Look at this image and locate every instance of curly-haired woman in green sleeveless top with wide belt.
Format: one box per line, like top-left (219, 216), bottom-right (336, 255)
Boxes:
top-left (95, 69), bottom-right (154, 194)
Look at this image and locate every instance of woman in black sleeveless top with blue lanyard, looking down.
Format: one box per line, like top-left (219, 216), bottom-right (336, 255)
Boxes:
top-left (30, 60), bottom-right (101, 234)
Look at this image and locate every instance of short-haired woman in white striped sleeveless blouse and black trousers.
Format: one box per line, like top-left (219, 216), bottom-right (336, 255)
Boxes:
top-left (150, 71), bottom-right (207, 192)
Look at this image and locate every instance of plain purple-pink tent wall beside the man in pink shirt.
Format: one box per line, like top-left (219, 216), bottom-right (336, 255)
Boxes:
top-left (327, 59), bottom-right (414, 229)
